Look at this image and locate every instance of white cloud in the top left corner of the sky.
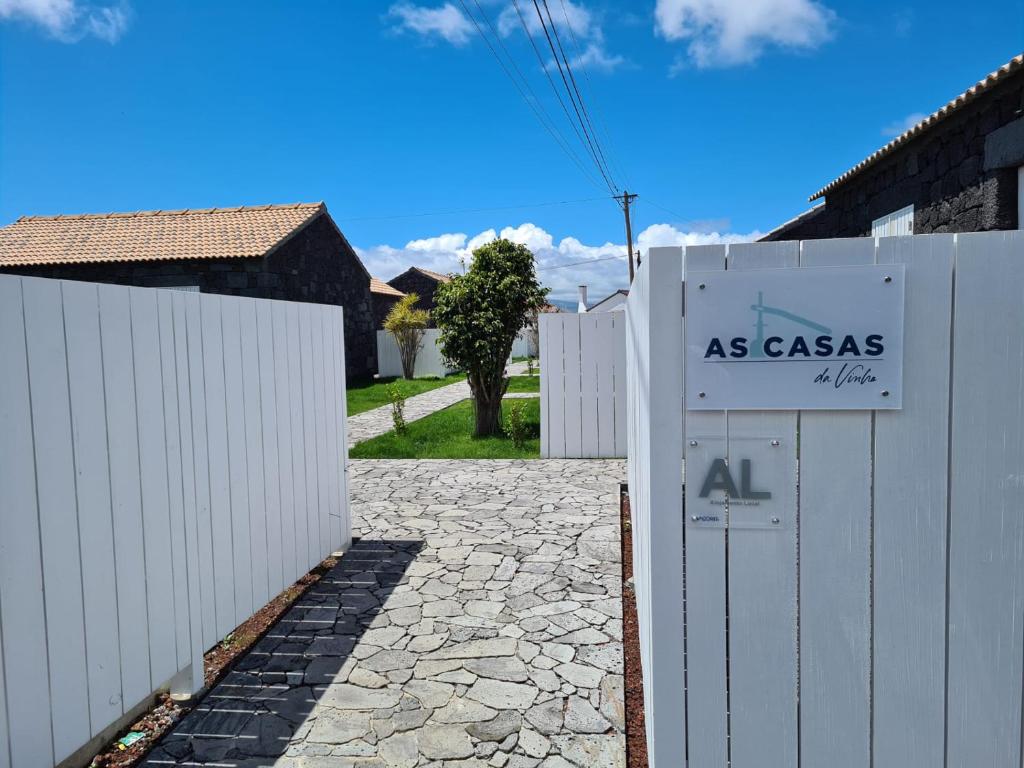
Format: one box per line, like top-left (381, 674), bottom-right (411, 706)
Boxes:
top-left (0, 0), bottom-right (131, 43)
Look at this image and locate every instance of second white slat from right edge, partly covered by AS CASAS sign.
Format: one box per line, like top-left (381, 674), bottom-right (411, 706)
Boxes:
top-left (873, 234), bottom-right (954, 768)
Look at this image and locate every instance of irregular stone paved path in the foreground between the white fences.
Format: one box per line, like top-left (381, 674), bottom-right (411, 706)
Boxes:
top-left (147, 460), bottom-right (625, 768)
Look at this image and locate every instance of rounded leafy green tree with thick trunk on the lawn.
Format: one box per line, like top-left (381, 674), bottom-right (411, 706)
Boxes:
top-left (433, 240), bottom-right (548, 437)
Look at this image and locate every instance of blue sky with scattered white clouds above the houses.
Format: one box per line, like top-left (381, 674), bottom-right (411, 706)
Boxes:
top-left (0, 0), bottom-right (1024, 297)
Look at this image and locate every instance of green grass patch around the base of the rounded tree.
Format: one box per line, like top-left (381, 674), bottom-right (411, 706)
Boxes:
top-left (348, 398), bottom-right (541, 459)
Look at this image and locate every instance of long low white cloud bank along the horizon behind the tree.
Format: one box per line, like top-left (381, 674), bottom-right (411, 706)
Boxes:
top-left (355, 221), bottom-right (761, 301)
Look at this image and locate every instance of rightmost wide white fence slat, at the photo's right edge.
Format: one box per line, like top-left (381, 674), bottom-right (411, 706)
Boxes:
top-left (947, 231), bottom-right (1024, 768)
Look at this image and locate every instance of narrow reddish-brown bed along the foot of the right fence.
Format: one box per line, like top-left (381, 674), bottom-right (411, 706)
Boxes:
top-left (620, 486), bottom-right (647, 768)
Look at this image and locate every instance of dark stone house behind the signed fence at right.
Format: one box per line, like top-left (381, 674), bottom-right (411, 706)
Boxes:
top-left (763, 54), bottom-right (1024, 241)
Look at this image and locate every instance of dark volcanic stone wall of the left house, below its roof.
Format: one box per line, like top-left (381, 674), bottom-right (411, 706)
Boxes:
top-left (4, 214), bottom-right (377, 379)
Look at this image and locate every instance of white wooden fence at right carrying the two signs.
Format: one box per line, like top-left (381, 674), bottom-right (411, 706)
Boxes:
top-left (628, 231), bottom-right (1024, 768)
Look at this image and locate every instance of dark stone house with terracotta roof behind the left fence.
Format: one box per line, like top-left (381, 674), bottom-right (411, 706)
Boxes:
top-left (0, 203), bottom-right (377, 378)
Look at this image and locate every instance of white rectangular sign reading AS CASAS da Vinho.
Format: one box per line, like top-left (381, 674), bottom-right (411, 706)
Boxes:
top-left (683, 264), bottom-right (904, 411)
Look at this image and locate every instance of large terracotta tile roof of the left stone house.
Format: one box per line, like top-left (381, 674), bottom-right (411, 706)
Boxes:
top-left (0, 203), bottom-right (327, 266)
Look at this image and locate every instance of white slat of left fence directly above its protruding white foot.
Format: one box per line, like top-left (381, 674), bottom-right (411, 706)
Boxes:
top-left (171, 291), bottom-right (206, 690)
